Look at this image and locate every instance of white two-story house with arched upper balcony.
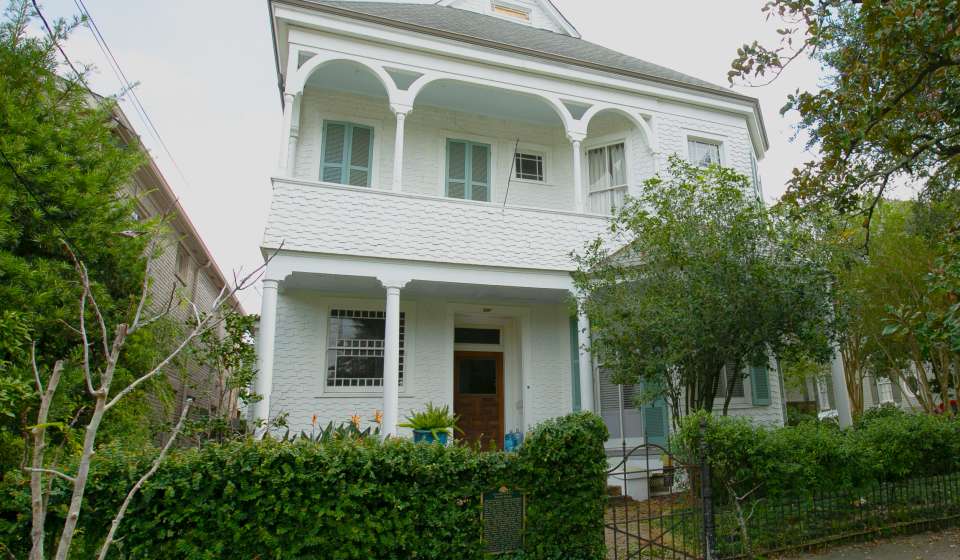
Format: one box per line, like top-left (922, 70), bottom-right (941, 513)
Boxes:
top-left (254, 0), bottom-right (783, 444)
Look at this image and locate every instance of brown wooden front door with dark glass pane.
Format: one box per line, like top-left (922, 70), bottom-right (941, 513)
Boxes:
top-left (453, 352), bottom-right (504, 449)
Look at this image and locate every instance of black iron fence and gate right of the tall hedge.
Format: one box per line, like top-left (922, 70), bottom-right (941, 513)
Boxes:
top-left (606, 422), bottom-right (960, 560)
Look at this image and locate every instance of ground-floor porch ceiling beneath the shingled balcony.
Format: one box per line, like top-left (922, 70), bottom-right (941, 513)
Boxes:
top-left (284, 272), bottom-right (569, 303)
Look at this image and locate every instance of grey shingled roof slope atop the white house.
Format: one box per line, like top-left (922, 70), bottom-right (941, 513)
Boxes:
top-left (301, 0), bottom-right (736, 96)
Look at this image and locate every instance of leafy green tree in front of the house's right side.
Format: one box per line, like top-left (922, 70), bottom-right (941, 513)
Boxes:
top-left (574, 157), bottom-right (830, 414)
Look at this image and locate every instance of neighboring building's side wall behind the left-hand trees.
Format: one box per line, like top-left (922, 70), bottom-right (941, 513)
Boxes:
top-left (115, 107), bottom-right (244, 419)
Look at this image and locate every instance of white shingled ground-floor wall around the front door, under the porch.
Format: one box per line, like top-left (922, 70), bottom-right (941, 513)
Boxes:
top-left (270, 289), bottom-right (572, 433)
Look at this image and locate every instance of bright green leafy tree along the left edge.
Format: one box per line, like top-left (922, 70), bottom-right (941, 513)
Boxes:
top-left (0, 0), bottom-right (154, 467)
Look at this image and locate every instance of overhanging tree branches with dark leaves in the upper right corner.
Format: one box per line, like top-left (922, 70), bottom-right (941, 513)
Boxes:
top-left (729, 0), bottom-right (960, 219)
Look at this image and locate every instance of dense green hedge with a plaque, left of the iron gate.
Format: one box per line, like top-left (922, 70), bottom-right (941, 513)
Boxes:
top-left (0, 413), bottom-right (607, 560)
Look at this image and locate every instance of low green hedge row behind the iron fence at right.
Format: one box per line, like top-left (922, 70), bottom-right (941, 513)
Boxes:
top-left (676, 409), bottom-right (960, 496)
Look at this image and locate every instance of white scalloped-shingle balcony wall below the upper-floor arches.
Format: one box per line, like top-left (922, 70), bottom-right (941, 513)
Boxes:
top-left (263, 180), bottom-right (607, 270)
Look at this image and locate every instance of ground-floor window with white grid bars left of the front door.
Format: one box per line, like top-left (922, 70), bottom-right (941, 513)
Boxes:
top-left (327, 309), bottom-right (406, 390)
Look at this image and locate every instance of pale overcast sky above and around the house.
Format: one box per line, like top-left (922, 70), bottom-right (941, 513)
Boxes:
top-left (43, 0), bottom-right (817, 312)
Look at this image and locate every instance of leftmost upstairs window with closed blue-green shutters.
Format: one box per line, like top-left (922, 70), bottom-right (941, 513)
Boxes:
top-left (320, 121), bottom-right (373, 187)
